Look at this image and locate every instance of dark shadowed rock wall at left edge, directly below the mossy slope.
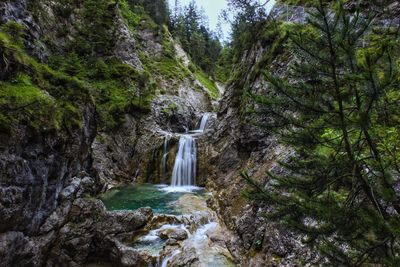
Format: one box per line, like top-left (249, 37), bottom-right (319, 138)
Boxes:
top-left (0, 104), bottom-right (95, 237)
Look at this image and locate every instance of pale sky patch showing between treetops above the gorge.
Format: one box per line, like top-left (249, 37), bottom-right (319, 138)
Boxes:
top-left (168, 0), bottom-right (276, 40)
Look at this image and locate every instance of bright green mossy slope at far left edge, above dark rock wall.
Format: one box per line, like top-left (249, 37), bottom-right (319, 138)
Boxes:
top-left (0, 22), bottom-right (90, 134)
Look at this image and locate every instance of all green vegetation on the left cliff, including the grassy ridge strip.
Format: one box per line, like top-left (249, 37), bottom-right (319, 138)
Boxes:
top-left (0, 0), bottom-right (225, 134)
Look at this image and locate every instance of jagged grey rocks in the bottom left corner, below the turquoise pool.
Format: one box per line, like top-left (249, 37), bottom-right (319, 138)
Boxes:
top-left (0, 177), bottom-right (153, 266)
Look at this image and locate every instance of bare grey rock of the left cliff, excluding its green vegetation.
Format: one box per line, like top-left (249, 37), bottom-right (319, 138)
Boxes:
top-left (0, 0), bottom-right (216, 266)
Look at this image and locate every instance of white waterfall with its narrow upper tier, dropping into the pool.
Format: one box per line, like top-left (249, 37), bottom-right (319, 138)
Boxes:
top-left (171, 113), bottom-right (209, 187)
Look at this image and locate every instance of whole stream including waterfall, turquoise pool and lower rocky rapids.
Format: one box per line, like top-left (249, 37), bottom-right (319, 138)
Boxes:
top-left (100, 114), bottom-right (235, 267)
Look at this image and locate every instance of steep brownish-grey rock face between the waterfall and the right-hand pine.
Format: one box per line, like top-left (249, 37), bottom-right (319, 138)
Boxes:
top-left (201, 10), bottom-right (320, 266)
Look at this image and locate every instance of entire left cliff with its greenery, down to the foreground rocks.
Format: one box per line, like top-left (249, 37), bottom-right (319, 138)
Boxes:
top-left (0, 0), bottom-right (216, 266)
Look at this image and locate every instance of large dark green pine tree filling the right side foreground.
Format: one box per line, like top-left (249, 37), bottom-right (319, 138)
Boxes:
top-left (243, 0), bottom-right (400, 266)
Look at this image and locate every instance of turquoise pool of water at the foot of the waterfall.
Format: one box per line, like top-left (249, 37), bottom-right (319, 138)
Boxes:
top-left (100, 184), bottom-right (205, 215)
